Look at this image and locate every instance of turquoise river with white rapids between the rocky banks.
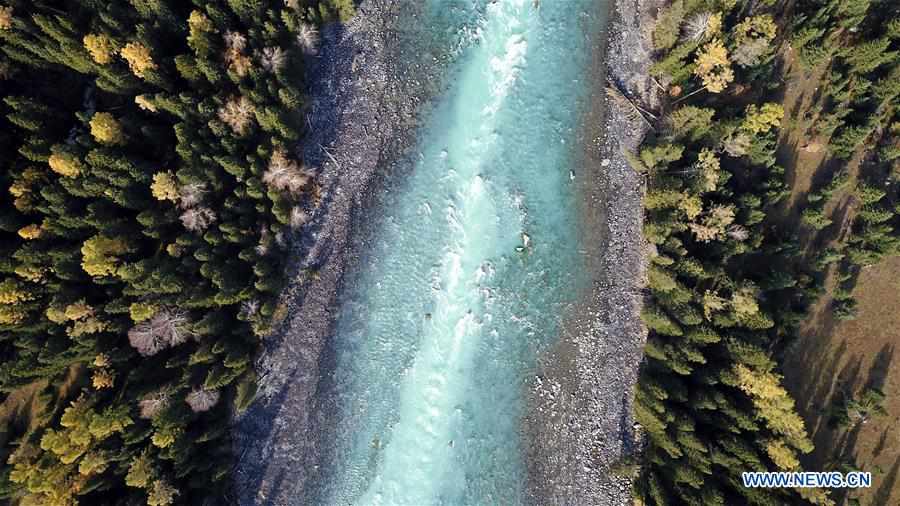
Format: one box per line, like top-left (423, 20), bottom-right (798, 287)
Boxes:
top-left (321, 0), bottom-right (599, 506)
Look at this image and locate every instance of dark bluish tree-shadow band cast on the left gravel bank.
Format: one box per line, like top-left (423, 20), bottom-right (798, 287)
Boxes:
top-left (231, 16), bottom-right (356, 506)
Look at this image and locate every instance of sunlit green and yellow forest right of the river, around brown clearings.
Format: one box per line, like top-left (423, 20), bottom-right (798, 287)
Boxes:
top-left (632, 0), bottom-right (900, 505)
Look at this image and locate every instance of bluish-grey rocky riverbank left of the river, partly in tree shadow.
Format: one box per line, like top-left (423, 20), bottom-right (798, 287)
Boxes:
top-left (234, 0), bottom-right (428, 506)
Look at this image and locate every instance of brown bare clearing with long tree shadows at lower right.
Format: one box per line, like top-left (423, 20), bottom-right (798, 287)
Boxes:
top-left (784, 257), bottom-right (900, 506)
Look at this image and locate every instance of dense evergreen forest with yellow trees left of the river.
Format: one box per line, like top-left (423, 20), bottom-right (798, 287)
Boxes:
top-left (0, 0), bottom-right (353, 506)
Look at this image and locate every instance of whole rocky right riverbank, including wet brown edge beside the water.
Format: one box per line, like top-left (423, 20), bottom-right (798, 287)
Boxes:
top-left (524, 0), bottom-right (660, 506)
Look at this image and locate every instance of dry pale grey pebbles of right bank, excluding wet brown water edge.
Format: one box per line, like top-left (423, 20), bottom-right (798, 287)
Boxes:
top-left (531, 0), bottom-right (661, 506)
